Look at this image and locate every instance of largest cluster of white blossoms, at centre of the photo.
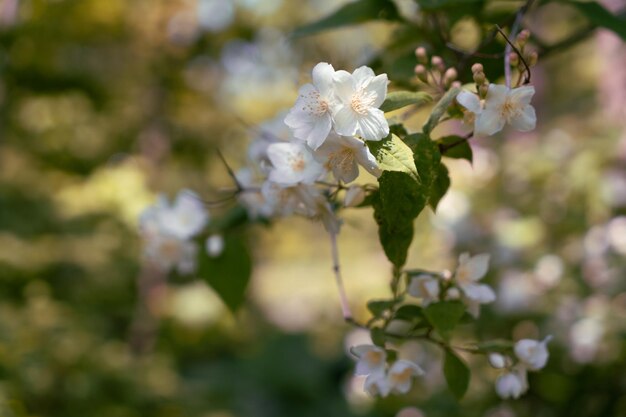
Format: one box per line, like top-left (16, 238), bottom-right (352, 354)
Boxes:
top-left (237, 63), bottom-right (389, 233)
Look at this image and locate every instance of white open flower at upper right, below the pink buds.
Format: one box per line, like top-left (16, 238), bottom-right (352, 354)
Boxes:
top-left (472, 84), bottom-right (537, 135)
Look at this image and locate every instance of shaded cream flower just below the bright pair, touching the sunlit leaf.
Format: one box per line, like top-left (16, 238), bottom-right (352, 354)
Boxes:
top-left (315, 134), bottom-right (382, 182)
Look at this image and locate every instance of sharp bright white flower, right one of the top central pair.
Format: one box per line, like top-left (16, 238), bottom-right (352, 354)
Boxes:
top-left (333, 66), bottom-right (389, 140)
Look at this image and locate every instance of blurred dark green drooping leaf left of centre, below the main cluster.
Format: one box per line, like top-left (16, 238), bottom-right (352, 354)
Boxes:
top-left (198, 237), bottom-right (252, 312)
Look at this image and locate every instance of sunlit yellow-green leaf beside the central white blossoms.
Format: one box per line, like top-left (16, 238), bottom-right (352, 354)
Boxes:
top-left (367, 134), bottom-right (419, 180)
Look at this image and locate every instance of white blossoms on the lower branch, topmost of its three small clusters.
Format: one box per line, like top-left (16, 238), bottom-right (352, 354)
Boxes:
top-left (407, 253), bottom-right (496, 317)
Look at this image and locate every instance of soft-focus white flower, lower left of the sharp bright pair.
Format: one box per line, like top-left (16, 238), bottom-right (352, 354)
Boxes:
top-left (267, 142), bottom-right (324, 186)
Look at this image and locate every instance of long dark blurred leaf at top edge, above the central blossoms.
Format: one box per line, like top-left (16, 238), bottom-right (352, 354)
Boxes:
top-left (292, 0), bottom-right (402, 36)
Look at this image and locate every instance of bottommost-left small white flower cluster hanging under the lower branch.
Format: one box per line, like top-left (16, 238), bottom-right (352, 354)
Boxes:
top-left (350, 345), bottom-right (424, 397)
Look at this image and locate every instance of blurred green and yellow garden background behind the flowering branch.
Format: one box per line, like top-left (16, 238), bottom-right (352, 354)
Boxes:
top-left (0, 0), bottom-right (626, 417)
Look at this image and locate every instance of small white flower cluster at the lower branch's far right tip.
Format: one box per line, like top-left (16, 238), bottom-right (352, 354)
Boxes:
top-left (489, 336), bottom-right (552, 399)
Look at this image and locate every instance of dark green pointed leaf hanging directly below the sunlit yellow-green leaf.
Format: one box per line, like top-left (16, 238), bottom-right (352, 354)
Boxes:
top-left (372, 171), bottom-right (426, 268)
